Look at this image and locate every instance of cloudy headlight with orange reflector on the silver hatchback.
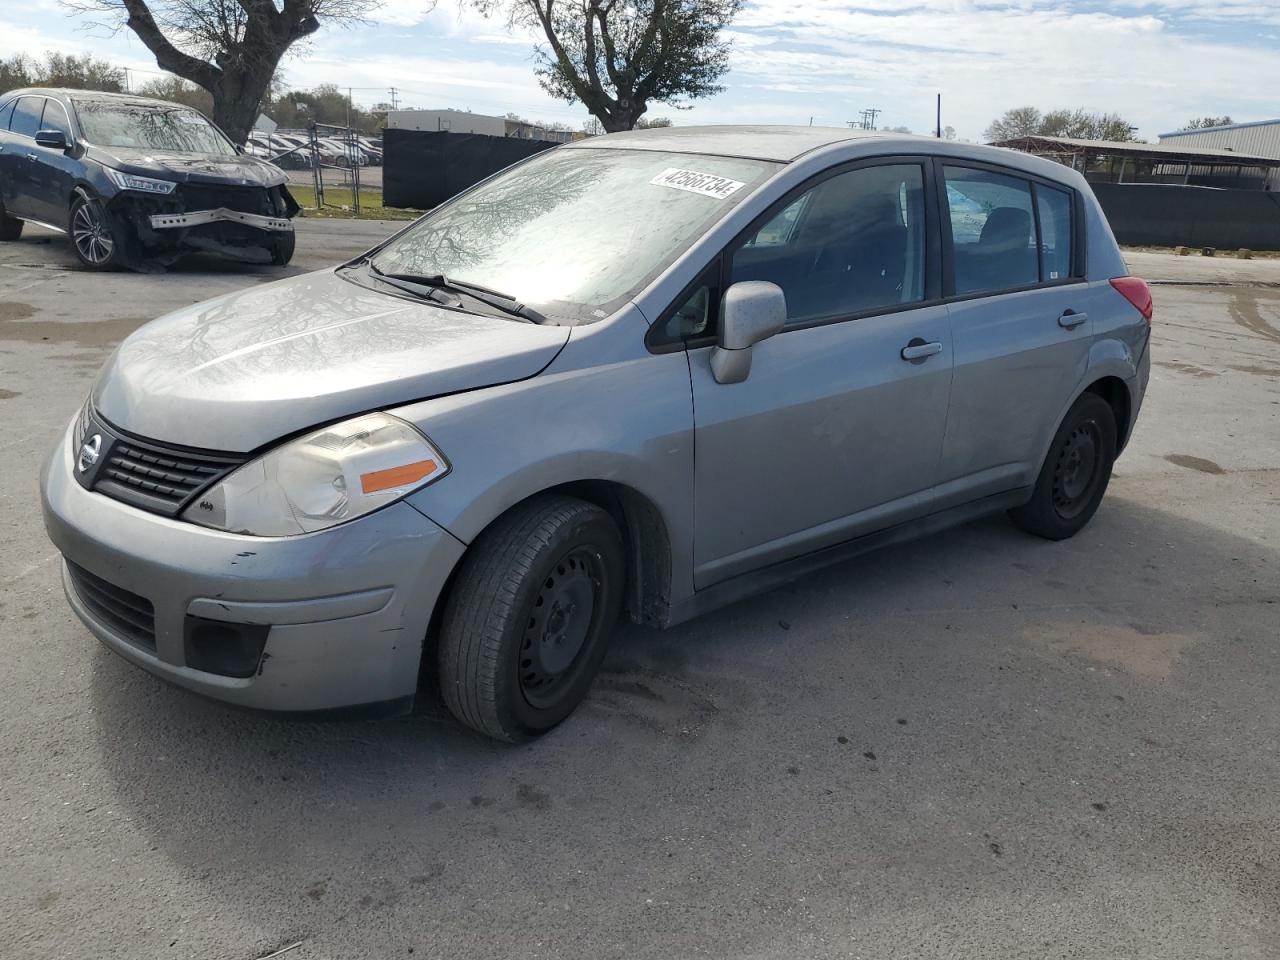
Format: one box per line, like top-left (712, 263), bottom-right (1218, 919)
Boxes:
top-left (182, 413), bottom-right (449, 536)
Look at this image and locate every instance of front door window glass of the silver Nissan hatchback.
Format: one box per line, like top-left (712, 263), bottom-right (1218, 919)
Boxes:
top-left (731, 164), bottom-right (925, 324)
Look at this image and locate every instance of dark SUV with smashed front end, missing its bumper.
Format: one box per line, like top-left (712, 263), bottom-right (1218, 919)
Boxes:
top-left (0, 90), bottom-right (298, 270)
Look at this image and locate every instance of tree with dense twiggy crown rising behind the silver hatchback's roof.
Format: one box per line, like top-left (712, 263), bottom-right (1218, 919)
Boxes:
top-left (471, 0), bottom-right (742, 133)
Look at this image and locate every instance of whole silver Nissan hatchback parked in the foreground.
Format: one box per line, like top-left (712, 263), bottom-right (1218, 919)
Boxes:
top-left (44, 127), bottom-right (1151, 740)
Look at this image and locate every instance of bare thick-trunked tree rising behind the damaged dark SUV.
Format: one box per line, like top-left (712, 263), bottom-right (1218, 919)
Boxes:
top-left (63, 0), bottom-right (376, 143)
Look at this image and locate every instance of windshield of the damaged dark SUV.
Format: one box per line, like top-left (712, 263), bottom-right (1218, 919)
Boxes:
top-left (76, 100), bottom-right (236, 156)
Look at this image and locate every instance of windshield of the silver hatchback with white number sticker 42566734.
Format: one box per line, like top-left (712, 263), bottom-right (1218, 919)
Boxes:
top-left (371, 148), bottom-right (780, 323)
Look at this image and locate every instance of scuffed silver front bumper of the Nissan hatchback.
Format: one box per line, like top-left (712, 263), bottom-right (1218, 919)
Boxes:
top-left (41, 424), bottom-right (465, 712)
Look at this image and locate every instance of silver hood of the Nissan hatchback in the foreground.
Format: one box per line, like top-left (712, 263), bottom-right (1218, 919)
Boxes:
top-left (93, 270), bottom-right (570, 453)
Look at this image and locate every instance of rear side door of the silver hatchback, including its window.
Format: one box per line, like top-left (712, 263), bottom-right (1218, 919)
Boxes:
top-left (934, 161), bottom-right (1093, 509)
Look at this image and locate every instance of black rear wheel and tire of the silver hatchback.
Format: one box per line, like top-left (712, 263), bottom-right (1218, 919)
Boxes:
top-left (1009, 393), bottom-right (1116, 540)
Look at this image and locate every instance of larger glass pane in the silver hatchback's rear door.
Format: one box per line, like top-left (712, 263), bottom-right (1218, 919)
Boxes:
top-left (943, 166), bottom-right (1039, 294)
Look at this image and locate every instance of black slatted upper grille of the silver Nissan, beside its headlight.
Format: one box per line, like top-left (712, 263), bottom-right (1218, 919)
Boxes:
top-left (77, 415), bottom-right (247, 517)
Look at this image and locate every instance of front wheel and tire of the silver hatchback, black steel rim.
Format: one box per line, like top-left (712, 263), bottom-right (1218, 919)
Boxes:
top-left (439, 495), bottom-right (626, 742)
